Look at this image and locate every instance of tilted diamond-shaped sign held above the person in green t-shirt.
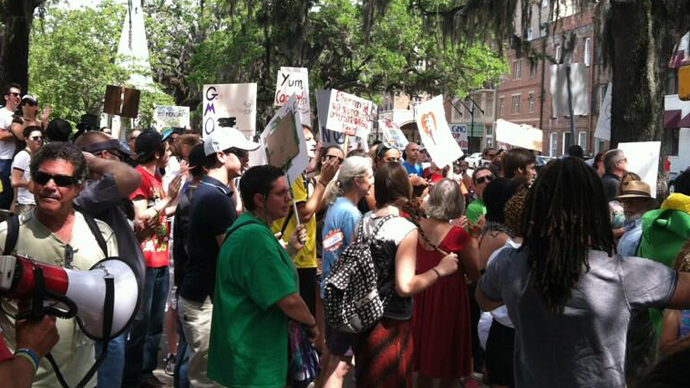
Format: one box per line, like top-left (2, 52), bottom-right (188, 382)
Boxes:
top-left (261, 95), bottom-right (309, 184)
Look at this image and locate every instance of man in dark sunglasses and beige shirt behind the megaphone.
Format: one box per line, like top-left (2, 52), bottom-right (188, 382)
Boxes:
top-left (0, 142), bottom-right (119, 388)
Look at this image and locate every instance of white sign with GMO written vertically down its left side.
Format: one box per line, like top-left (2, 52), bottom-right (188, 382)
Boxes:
top-left (202, 83), bottom-right (256, 138)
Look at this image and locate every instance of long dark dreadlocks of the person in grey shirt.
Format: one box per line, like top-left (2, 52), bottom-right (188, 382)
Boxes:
top-left (520, 158), bottom-right (615, 314)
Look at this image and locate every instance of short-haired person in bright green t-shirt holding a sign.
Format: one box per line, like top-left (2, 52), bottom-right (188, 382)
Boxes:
top-left (208, 166), bottom-right (318, 388)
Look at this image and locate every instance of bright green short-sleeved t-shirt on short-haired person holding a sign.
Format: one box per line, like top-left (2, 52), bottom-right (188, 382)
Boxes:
top-left (208, 213), bottom-right (297, 387)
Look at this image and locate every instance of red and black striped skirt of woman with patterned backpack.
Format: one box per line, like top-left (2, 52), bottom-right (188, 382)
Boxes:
top-left (352, 318), bottom-right (414, 388)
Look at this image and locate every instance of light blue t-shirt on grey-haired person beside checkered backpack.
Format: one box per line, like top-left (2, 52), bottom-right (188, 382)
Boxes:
top-left (321, 197), bottom-right (362, 298)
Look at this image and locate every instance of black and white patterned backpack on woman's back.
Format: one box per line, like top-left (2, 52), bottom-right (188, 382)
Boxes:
top-left (324, 215), bottom-right (396, 333)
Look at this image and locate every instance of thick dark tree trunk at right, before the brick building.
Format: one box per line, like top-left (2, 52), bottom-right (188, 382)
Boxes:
top-left (611, 0), bottom-right (673, 148)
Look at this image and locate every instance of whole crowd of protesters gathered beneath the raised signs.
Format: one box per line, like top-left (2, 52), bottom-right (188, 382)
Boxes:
top-left (0, 80), bottom-right (690, 388)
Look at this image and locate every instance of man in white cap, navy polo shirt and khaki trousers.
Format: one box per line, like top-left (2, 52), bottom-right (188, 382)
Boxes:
top-left (178, 127), bottom-right (259, 388)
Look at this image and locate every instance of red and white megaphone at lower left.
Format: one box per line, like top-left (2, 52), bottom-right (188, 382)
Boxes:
top-left (0, 255), bottom-right (139, 341)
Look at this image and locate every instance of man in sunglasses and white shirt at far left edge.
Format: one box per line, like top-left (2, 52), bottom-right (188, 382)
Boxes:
top-left (0, 83), bottom-right (22, 209)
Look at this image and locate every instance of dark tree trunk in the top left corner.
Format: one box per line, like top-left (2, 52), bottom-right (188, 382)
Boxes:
top-left (0, 0), bottom-right (44, 90)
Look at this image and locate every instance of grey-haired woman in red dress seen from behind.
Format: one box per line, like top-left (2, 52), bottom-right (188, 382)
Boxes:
top-left (412, 179), bottom-right (479, 388)
